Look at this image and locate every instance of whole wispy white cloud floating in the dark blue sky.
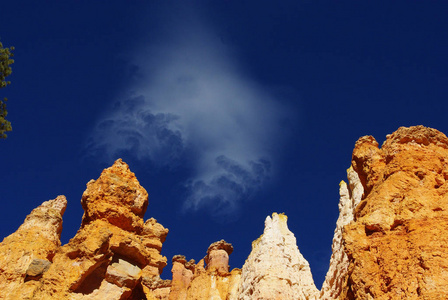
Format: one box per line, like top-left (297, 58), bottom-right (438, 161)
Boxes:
top-left (89, 13), bottom-right (287, 217)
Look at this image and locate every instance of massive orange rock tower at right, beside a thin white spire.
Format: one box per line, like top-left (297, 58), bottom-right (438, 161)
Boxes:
top-left (341, 126), bottom-right (448, 299)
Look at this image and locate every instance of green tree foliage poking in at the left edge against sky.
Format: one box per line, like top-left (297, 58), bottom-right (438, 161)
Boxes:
top-left (0, 42), bottom-right (14, 139)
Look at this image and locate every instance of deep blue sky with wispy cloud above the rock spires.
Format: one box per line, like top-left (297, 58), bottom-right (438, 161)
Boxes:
top-left (0, 0), bottom-right (448, 287)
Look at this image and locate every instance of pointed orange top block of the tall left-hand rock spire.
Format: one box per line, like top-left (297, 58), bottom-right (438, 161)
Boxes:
top-left (81, 159), bottom-right (148, 231)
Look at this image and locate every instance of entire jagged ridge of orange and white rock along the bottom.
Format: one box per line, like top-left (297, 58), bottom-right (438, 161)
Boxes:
top-left (0, 126), bottom-right (448, 300)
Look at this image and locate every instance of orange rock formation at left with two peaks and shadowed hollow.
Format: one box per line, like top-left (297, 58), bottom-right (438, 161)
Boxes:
top-left (0, 160), bottom-right (168, 299)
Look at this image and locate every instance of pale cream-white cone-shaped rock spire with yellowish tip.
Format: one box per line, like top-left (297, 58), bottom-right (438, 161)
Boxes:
top-left (237, 213), bottom-right (319, 300)
